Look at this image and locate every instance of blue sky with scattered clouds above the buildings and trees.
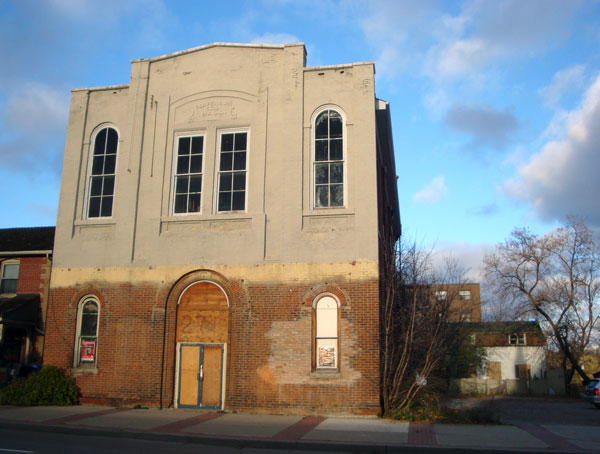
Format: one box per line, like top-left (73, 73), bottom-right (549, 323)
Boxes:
top-left (0, 0), bottom-right (600, 280)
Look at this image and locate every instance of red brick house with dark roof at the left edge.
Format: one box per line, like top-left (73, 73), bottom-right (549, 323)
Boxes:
top-left (0, 227), bottom-right (54, 383)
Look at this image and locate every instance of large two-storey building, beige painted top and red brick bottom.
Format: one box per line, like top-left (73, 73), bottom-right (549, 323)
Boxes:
top-left (44, 43), bottom-right (400, 414)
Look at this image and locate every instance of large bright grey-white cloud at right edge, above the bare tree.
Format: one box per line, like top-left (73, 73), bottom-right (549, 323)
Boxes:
top-left (504, 76), bottom-right (600, 231)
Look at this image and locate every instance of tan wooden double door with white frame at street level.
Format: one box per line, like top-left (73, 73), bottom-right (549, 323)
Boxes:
top-left (177, 344), bottom-right (225, 409)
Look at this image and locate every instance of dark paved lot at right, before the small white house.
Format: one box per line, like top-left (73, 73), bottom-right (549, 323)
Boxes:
top-left (447, 396), bottom-right (600, 426)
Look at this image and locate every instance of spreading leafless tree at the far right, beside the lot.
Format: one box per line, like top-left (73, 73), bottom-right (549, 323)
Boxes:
top-left (484, 217), bottom-right (600, 383)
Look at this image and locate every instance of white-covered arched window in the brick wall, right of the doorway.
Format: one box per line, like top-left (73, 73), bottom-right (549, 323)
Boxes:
top-left (314, 295), bottom-right (339, 369)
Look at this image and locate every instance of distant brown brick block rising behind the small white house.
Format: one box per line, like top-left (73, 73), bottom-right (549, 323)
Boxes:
top-left (434, 283), bottom-right (481, 322)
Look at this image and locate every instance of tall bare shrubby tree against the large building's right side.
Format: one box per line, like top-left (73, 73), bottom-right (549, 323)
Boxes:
top-left (380, 242), bottom-right (468, 415)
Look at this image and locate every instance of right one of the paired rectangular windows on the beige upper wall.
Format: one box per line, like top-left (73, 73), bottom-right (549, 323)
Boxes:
top-left (217, 131), bottom-right (248, 212)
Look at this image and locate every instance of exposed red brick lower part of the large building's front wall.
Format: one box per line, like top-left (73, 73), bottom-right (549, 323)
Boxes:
top-left (44, 271), bottom-right (379, 414)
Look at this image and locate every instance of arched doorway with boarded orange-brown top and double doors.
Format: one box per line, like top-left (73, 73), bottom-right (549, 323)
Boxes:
top-left (175, 281), bottom-right (229, 409)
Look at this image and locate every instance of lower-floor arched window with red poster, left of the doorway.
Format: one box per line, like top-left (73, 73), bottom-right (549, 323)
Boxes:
top-left (75, 296), bottom-right (100, 366)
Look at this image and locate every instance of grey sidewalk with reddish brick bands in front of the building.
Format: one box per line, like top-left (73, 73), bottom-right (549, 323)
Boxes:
top-left (0, 405), bottom-right (600, 453)
